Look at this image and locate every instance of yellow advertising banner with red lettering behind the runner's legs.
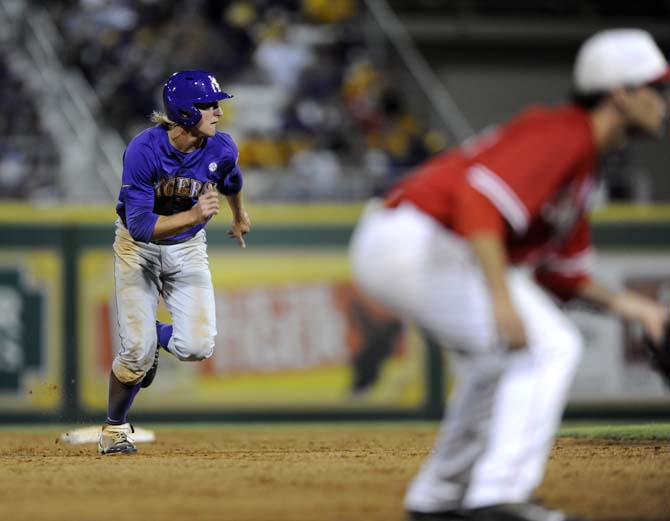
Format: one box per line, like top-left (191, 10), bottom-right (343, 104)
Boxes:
top-left (79, 246), bottom-right (425, 411)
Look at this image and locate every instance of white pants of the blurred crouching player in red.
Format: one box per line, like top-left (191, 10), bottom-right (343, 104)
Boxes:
top-left (350, 203), bottom-right (582, 512)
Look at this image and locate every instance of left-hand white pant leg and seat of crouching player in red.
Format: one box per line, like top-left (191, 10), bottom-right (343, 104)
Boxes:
top-left (350, 206), bottom-right (502, 512)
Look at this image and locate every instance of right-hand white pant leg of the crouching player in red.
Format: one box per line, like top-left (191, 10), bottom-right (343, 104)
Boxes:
top-left (464, 272), bottom-right (582, 507)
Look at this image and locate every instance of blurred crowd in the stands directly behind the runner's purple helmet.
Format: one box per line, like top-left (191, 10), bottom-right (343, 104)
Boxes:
top-left (48, 0), bottom-right (446, 197)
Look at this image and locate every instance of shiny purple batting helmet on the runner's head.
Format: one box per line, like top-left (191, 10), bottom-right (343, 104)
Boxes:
top-left (163, 70), bottom-right (232, 127)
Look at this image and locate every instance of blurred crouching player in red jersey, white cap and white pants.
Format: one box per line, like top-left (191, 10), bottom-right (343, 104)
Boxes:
top-left (350, 29), bottom-right (670, 521)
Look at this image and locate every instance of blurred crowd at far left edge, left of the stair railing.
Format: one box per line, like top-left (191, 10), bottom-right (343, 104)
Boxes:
top-left (0, 54), bottom-right (58, 199)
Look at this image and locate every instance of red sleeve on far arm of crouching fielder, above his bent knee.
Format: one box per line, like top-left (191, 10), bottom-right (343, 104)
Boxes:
top-left (535, 215), bottom-right (592, 300)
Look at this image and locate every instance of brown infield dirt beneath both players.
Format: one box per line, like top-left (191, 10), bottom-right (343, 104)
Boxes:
top-left (0, 424), bottom-right (670, 521)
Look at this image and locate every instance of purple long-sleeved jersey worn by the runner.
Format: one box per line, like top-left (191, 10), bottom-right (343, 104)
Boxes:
top-left (116, 125), bottom-right (242, 244)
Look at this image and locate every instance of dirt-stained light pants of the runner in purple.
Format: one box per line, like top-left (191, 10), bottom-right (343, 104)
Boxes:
top-left (112, 222), bottom-right (216, 384)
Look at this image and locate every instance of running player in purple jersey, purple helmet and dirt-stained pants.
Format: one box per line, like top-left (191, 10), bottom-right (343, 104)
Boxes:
top-left (99, 70), bottom-right (251, 454)
